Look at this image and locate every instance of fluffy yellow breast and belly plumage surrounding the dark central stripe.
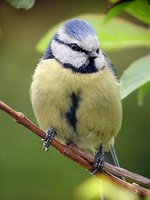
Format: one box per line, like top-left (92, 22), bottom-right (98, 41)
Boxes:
top-left (31, 59), bottom-right (122, 148)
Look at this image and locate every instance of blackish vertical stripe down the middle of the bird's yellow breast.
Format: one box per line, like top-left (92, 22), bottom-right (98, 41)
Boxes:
top-left (65, 93), bottom-right (80, 131)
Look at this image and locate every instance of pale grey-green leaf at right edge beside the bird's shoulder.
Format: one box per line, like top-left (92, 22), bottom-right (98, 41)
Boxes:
top-left (121, 55), bottom-right (150, 99)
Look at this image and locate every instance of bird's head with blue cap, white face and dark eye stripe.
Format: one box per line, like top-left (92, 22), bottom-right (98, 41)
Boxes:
top-left (44, 19), bottom-right (105, 73)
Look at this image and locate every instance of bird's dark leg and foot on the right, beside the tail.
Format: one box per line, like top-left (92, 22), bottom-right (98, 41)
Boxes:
top-left (92, 145), bottom-right (104, 174)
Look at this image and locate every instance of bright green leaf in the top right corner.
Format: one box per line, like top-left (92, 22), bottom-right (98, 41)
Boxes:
top-left (125, 0), bottom-right (150, 24)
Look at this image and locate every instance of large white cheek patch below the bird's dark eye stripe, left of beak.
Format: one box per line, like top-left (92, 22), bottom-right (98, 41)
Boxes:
top-left (51, 41), bottom-right (87, 68)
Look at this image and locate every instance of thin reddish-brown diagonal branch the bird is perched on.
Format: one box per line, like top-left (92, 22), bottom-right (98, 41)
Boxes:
top-left (0, 101), bottom-right (150, 196)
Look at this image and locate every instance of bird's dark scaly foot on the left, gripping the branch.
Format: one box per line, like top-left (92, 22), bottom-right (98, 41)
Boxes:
top-left (43, 128), bottom-right (56, 151)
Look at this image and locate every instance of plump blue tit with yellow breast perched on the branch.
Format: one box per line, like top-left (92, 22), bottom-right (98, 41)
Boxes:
top-left (31, 19), bottom-right (122, 173)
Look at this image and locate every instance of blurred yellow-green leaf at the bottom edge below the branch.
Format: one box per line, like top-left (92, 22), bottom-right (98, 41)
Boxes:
top-left (75, 175), bottom-right (139, 200)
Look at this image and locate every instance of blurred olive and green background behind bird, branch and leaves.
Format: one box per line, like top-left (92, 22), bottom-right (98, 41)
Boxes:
top-left (0, 0), bottom-right (150, 200)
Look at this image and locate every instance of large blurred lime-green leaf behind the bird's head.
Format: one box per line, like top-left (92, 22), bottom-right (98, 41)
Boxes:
top-left (36, 14), bottom-right (150, 53)
